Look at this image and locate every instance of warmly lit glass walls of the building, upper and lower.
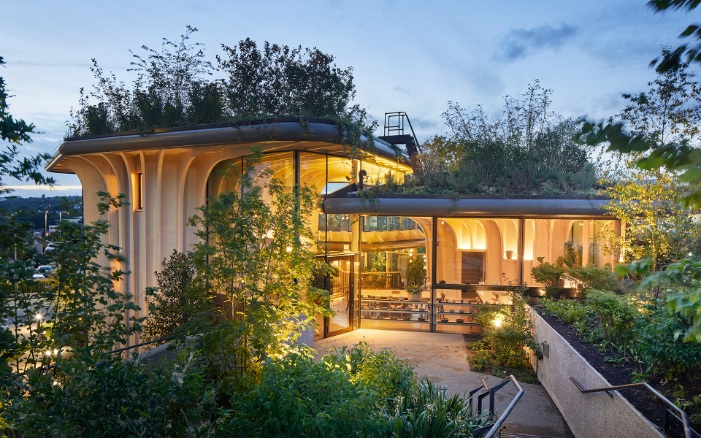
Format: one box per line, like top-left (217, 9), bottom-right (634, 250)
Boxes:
top-left (208, 151), bottom-right (620, 338)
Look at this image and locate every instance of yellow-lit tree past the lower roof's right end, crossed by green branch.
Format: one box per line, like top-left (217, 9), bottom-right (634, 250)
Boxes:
top-left (605, 65), bottom-right (701, 270)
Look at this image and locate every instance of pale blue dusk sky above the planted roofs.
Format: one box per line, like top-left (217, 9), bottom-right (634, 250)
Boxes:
top-left (0, 0), bottom-right (701, 196)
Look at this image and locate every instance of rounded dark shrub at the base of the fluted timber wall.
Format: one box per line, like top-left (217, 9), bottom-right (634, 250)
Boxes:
top-left (144, 250), bottom-right (213, 340)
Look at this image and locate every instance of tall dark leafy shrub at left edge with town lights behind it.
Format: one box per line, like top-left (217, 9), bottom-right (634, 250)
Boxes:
top-left (0, 194), bottom-right (141, 435)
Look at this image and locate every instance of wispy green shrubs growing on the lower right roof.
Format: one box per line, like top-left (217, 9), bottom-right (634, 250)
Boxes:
top-left (405, 81), bottom-right (595, 196)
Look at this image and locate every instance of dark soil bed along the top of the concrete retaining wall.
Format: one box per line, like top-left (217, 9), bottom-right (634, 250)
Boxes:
top-left (533, 304), bottom-right (701, 436)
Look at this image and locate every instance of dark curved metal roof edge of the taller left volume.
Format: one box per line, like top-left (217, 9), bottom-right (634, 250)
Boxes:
top-left (46, 119), bottom-right (409, 172)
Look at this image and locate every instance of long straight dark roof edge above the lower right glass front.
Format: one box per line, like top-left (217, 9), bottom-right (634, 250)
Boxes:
top-left (320, 196), bottom-right (614, 219)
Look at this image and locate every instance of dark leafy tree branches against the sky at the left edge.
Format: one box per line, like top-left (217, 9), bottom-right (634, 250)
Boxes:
top-left (0, 56), bottom-right (54, 194)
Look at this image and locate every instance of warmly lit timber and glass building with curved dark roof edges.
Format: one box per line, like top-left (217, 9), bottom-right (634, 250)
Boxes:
top-left (47, 119), bottom-right (620, 337)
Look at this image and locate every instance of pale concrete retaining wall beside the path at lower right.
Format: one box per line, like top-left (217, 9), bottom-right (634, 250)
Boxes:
top-left (530, 309), bottom-right (664, 438)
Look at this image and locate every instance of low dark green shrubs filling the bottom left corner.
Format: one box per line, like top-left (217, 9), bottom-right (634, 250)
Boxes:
top-left (5, 349), bottom-right (218, 437)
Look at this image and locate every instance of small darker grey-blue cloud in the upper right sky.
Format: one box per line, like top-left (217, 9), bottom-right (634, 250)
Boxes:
top-left (496, 24), bottom-right (579, 62)
